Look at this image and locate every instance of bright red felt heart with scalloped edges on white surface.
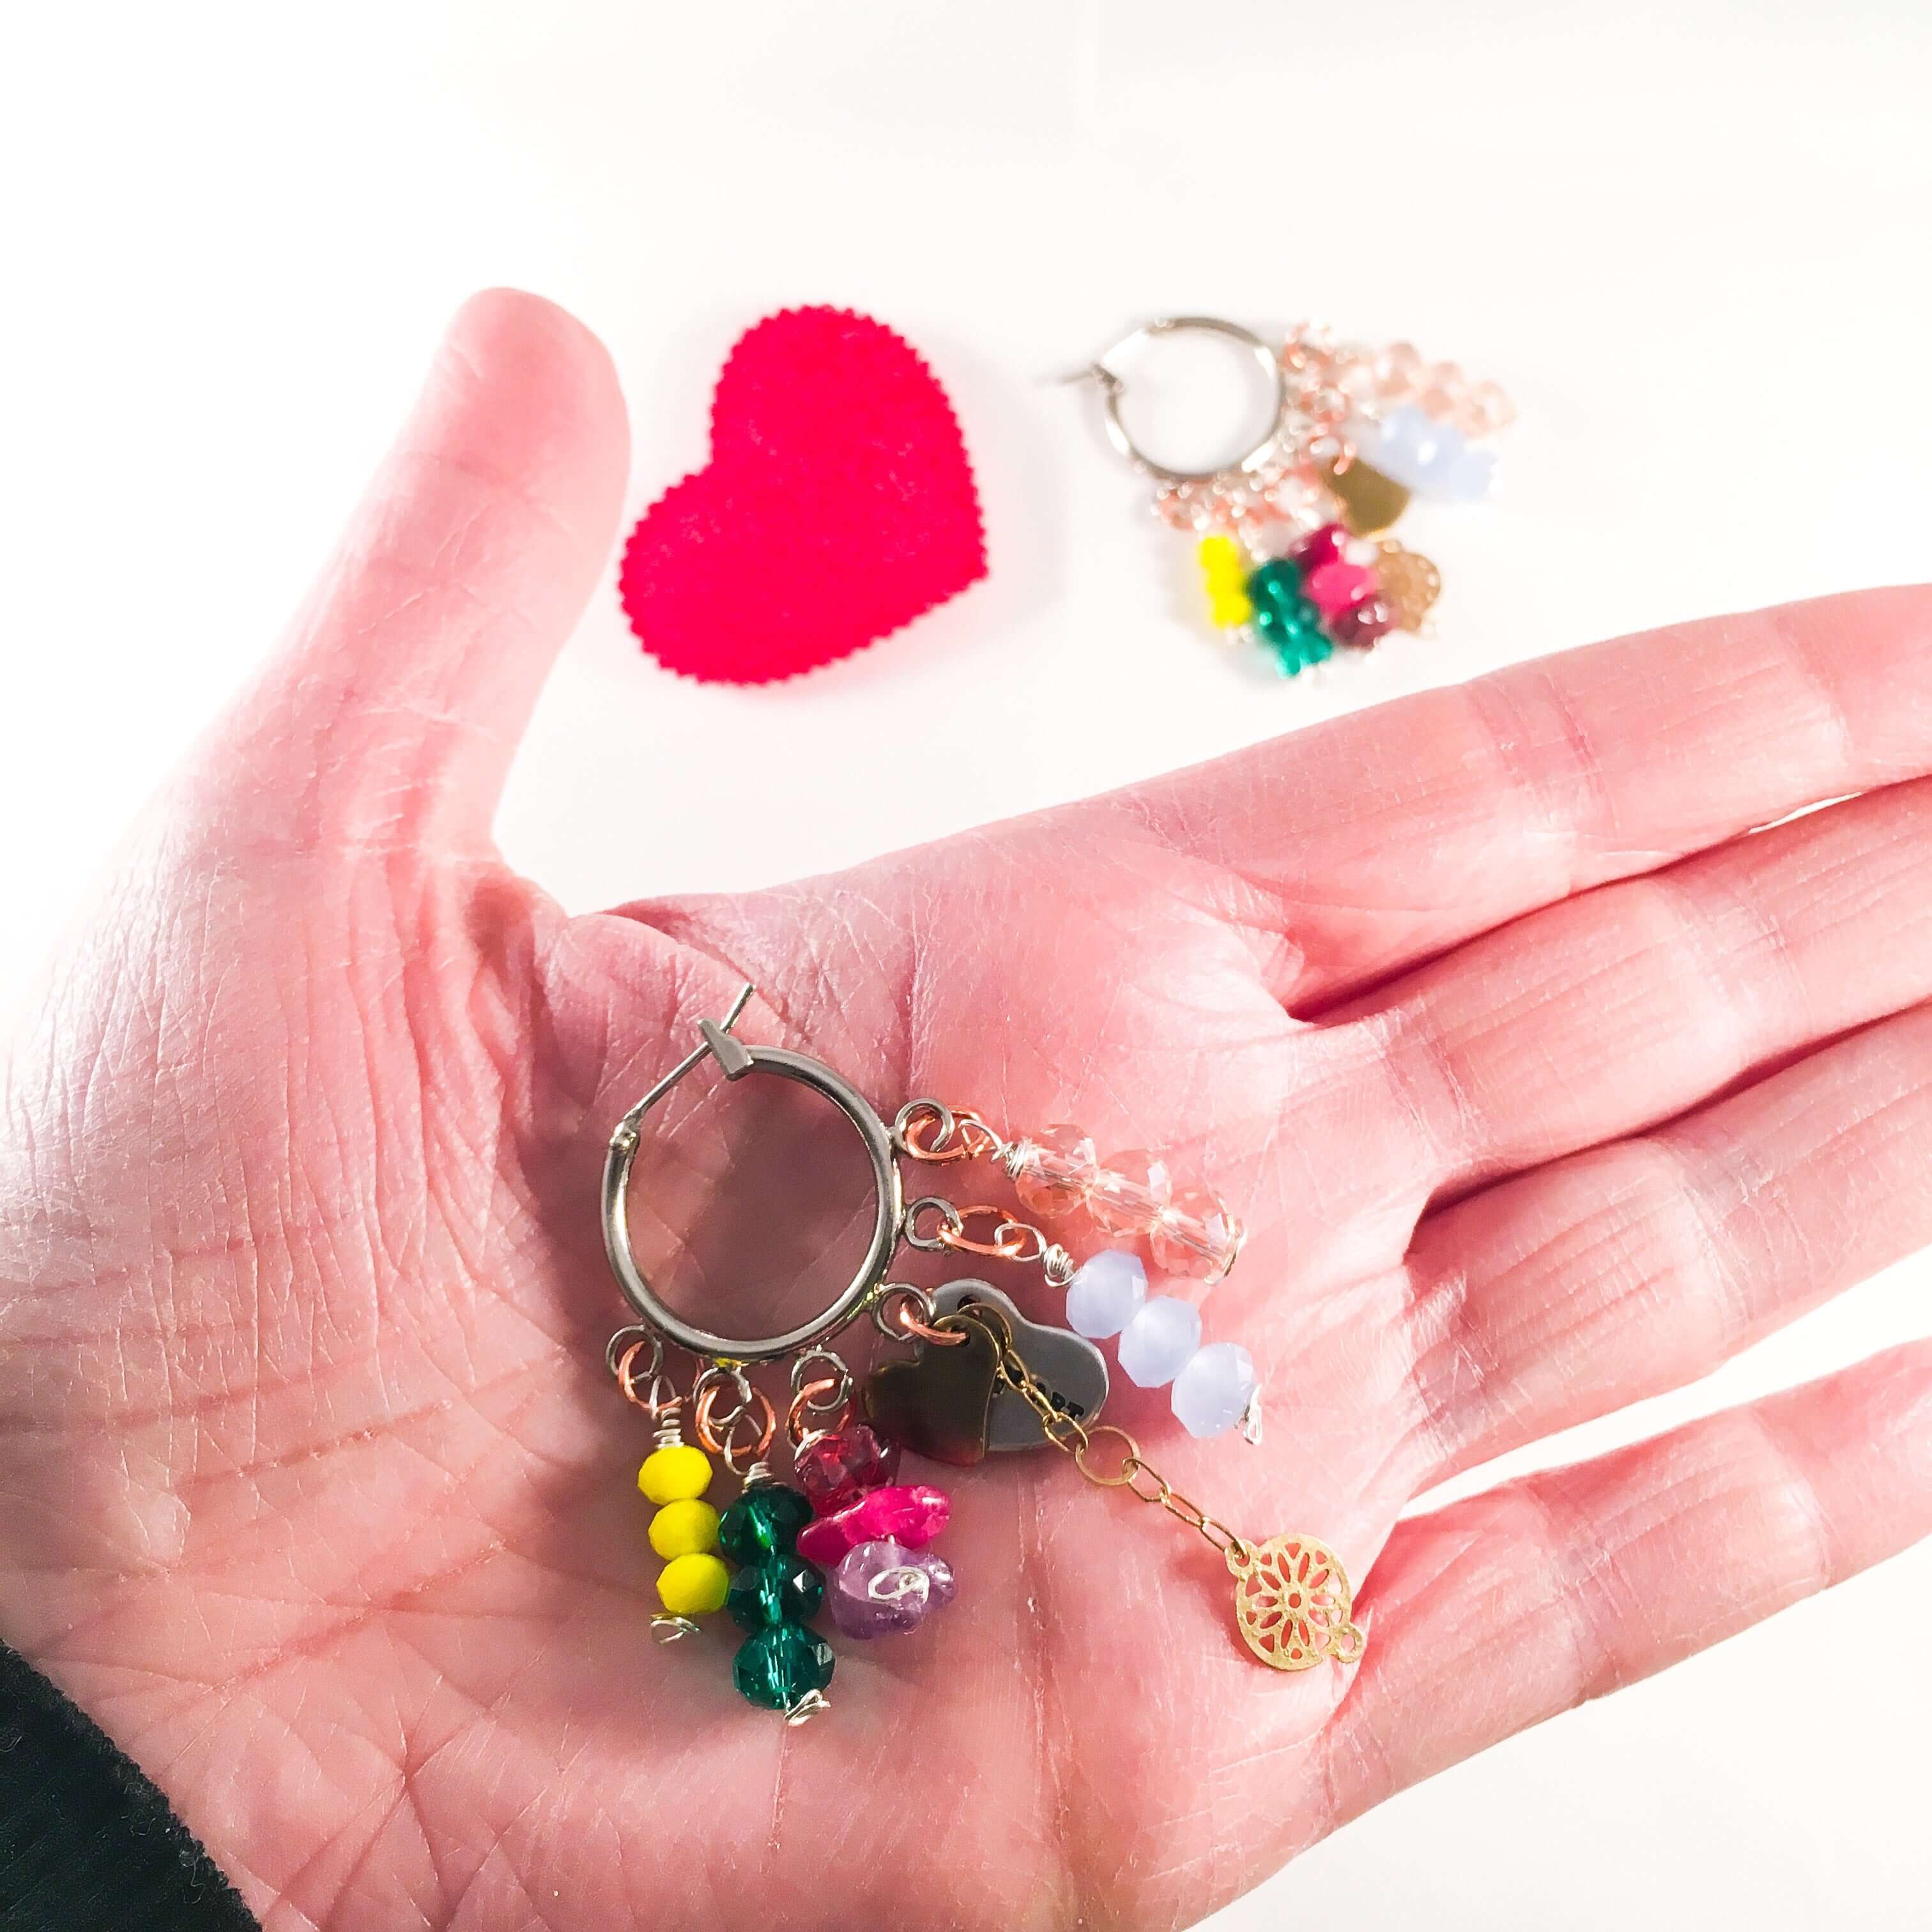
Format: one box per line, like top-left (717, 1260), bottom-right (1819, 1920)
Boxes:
top-left (618, 309), bottom-right (985, 684)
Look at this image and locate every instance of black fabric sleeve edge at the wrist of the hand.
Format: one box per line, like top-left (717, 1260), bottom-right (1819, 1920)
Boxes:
top-left (0, 1644), bottom-right (259, 1932)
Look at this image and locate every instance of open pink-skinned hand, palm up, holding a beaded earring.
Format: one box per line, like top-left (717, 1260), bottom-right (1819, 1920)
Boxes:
top-left (0, 294), bottom-right (1932, 1932)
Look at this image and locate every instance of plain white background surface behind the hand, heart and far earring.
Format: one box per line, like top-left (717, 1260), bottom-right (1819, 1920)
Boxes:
top-left (0, 0), bottom-right (1932, 1932)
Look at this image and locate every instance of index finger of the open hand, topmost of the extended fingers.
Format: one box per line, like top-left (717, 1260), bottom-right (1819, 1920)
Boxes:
top-left (1094, 585), bottom-right (1932, 1009)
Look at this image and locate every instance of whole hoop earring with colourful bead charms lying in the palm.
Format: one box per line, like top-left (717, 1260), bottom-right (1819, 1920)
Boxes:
top-left (605, 987), bottom-right (1362, 1723)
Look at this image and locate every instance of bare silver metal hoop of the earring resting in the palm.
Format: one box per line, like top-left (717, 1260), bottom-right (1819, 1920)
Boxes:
top-left (602, 983), bottom-right (906, 1362)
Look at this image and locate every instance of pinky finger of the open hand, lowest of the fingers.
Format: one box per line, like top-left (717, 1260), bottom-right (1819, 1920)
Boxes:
top-left (1327, 1343), bottom-right (1932, 1828)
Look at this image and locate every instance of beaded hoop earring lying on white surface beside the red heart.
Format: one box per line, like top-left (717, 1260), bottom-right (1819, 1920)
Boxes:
top-left (1068, 315), bottom-right (1515, 676)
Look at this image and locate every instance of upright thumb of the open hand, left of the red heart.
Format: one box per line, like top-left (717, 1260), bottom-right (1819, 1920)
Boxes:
top-left (195, 290), bottom-right (630, 847)
